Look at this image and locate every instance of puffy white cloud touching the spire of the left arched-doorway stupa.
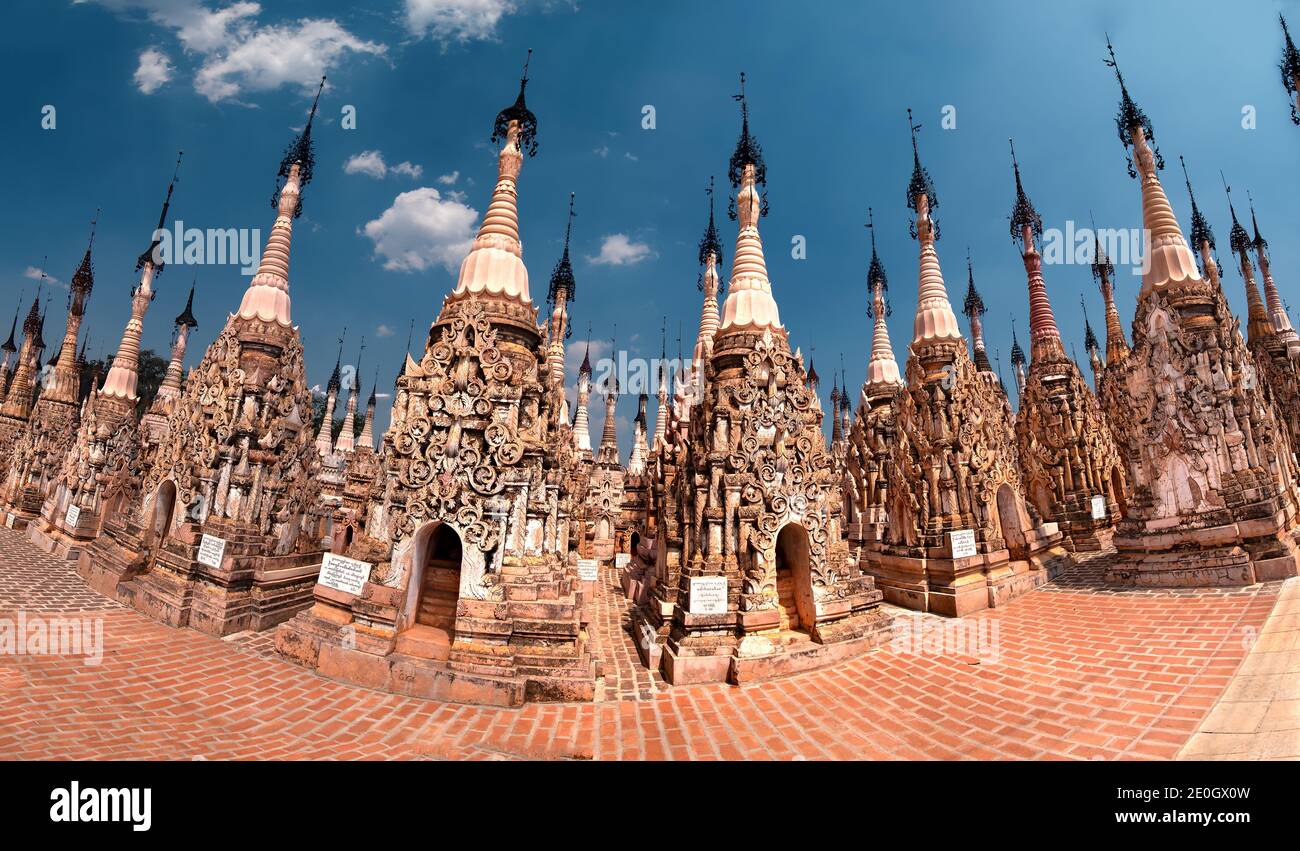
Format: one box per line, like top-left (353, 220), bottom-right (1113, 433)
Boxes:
top-left (363, 186), bottom-right (478, 272)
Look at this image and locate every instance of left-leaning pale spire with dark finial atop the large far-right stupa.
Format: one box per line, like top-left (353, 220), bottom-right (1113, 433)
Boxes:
top-left (1106, 38), bottom-right (1201, 300)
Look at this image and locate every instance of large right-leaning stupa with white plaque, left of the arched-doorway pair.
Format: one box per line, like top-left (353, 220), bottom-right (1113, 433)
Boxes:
top-left (78, 78), bottom-right (325, 635)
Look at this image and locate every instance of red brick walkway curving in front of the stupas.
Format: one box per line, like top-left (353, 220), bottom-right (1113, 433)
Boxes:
top-left (0, 530), bottom-right (1278, 759)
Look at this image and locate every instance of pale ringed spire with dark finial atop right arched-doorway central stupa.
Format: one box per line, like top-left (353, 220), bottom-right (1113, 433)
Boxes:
top-left (718, 74), bottom-right (784, 334)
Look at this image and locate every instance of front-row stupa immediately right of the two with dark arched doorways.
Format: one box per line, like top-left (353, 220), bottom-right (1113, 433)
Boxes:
top-left (863, 110), bottom-right (1069, 616)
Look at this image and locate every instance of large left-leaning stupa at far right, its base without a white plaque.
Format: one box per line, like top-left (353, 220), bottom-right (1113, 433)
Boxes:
top-left (1102, 43), bottom-right (1300, 586)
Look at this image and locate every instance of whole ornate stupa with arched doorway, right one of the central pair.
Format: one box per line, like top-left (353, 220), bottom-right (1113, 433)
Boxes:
top-left (659, 75), bottom-right (888, 683)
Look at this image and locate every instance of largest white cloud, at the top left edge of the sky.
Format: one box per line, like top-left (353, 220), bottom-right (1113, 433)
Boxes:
top-left (85, 0), bottom-right (387, 103)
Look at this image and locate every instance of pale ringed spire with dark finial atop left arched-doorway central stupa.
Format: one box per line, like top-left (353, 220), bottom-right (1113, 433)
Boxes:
top-left (447, 49), bottom-right (537, 305)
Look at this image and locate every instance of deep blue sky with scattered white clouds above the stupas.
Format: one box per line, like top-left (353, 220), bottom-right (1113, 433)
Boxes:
top-left (0, 0), bottom-right (1300, 453)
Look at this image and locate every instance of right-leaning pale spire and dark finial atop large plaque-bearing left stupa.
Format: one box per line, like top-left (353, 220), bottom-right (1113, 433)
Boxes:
top-left (237, 77), bottom-right (325, 327)
